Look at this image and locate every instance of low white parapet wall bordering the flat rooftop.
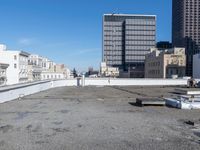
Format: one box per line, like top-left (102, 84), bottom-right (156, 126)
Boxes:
top-left (0, 78), bottom-right (187, 103)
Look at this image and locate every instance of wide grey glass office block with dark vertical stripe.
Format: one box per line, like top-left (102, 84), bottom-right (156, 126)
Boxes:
top-left (103, 14), bottom-right (156, 78)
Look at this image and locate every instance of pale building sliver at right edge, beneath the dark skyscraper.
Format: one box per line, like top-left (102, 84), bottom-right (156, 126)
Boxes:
top-left (193, 54), bottom-right (200, 79)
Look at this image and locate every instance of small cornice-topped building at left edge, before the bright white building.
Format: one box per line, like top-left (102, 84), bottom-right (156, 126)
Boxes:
top-left (0, 63), bottom-right (9, 86)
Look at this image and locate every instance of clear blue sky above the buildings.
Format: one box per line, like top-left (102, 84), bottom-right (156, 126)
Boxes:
top-left (0, 0), bottom-right (171, 71)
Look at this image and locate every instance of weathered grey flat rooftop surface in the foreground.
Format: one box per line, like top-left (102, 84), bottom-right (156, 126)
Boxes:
top-left (0, 87), bottom-right (200, 150)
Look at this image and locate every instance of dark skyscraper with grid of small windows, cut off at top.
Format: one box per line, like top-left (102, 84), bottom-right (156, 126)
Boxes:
top-left (172, 0), bottom-right (200, 76)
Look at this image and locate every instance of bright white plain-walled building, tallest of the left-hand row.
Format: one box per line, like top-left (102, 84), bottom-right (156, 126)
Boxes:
top-left (0, 45), bottom-right (29, 85)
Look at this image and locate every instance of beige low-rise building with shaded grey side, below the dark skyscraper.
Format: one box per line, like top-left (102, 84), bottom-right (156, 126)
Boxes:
top-left (145, 48), bottom-right (186, 78)
